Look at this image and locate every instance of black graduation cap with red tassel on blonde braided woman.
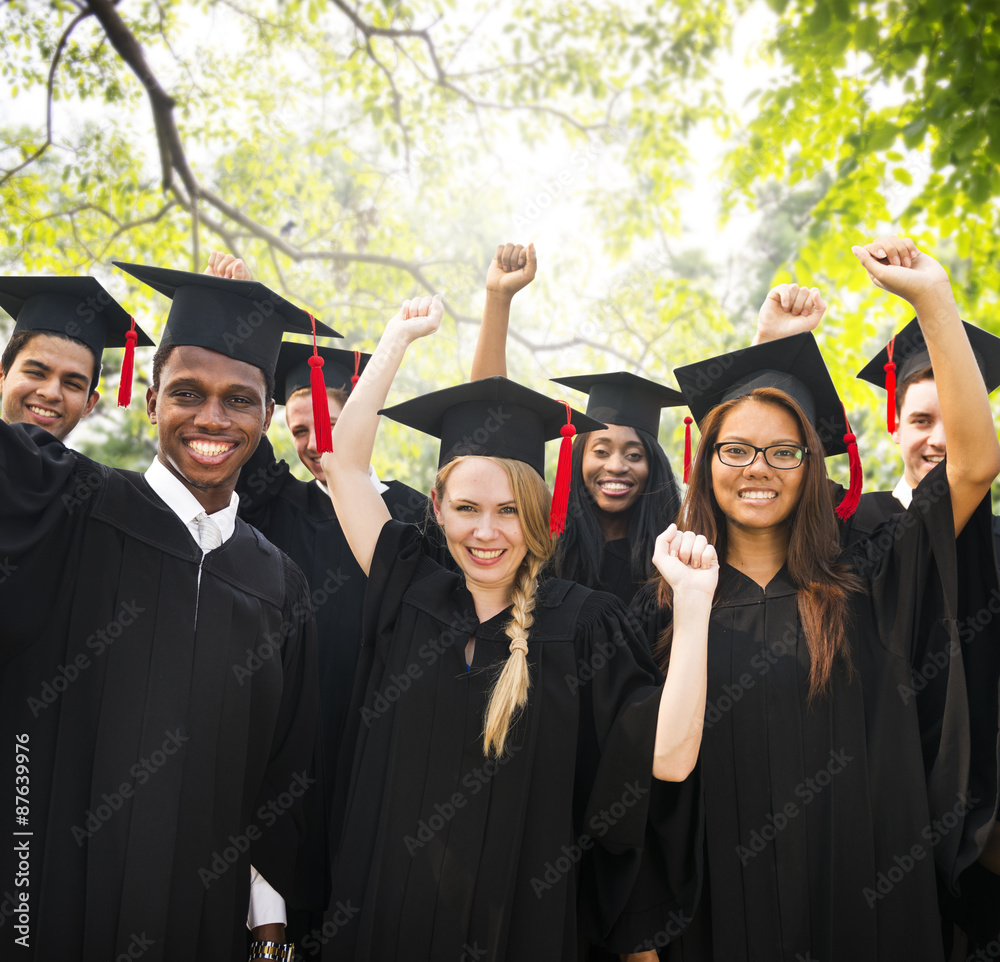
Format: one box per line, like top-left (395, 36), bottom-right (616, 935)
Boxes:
top-left (379, 377), bottom-right (605, 535)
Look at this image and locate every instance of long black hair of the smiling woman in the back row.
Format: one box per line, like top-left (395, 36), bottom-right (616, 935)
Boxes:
top-left (555, 428), bottom-right (681, 588)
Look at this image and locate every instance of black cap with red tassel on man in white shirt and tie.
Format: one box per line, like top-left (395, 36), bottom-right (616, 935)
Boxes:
top-left (112, 261), bottom-right (340, 453)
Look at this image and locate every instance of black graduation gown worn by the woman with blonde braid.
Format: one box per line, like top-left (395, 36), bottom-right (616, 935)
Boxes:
top-left (320, 522), bottom-right (696, 962)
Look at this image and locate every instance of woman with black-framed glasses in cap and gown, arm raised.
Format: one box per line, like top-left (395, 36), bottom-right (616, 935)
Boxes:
top-left (637, 237), bottom-right (1000, 962)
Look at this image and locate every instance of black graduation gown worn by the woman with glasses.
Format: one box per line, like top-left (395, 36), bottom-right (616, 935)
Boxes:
top-left (636, 468), bottom-right (996, 962)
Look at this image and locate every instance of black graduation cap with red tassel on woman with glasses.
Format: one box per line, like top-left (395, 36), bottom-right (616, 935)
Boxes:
top-left (674, 331), bottom-right (863, 520)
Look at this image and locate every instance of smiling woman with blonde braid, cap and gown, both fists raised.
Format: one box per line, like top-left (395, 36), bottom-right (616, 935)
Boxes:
top-left (316, 298), bottom-right (717, 962)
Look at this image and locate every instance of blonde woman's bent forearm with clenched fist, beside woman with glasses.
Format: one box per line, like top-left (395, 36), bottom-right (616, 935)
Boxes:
top-left (653, 524), bottom-right (719, 782)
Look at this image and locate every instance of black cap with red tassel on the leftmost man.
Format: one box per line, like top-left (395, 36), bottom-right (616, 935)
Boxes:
top-left (0, 276), bottom-right (153, 407)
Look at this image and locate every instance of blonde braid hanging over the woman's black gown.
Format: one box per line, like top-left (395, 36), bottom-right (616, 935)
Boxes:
top-left (483, 554), bottom-right (546, 757)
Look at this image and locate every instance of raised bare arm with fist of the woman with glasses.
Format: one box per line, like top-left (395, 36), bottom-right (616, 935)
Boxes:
top-left (851, 236), bottom-right (1000, 535)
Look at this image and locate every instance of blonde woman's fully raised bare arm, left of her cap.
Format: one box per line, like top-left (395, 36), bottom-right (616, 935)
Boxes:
top-left (320, 294), bottom-right (443, 575)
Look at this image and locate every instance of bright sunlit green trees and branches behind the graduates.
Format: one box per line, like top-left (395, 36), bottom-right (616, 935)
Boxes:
top-left (0, 0), bottom-right (1000, 496)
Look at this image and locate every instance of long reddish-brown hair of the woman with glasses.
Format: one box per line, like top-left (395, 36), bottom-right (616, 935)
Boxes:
top-left (659, 388), bottom-right (862, 700)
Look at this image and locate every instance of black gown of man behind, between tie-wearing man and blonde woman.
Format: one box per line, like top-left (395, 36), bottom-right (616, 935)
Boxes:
top-left (236, 437), bottom-right (427, 794)
